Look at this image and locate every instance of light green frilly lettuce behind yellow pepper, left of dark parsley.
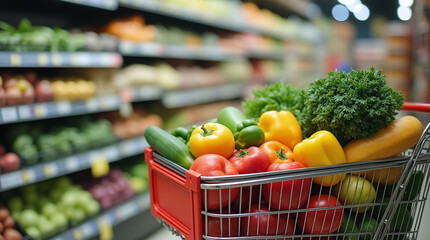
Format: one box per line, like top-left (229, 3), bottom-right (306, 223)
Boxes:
top-left (242, 81), bottom-right (305, 123)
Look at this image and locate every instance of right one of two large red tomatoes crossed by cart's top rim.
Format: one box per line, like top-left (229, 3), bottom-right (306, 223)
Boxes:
top-left (263, 162), bottom-right (312, 210)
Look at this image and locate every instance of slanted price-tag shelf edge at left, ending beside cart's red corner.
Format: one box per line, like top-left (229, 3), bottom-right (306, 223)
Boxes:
top-left (0, 137), bottom-right (148, 192)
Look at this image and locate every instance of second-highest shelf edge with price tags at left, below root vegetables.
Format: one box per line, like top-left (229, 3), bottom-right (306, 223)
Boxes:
top-left (0, 86), bottom-right (162, 125)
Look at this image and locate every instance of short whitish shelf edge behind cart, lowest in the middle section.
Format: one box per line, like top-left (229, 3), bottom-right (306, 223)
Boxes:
top-left (161, 82), bottom-right (246, 108)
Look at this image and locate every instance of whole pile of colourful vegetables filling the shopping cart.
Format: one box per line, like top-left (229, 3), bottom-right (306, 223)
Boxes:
top-left (144, 68), bottom-right (423, 240)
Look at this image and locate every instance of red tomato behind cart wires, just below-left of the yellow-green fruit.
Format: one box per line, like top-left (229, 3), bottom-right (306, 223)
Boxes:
top-left (297, 194), bottom-right (344, 234)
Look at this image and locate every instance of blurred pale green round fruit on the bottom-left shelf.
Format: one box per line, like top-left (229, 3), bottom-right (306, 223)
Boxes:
top-left (1, 176), bottom-right (100, 239)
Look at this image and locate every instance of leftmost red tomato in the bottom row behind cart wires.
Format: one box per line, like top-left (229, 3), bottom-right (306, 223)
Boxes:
top-left (202, 209), bottom-right (240, 237)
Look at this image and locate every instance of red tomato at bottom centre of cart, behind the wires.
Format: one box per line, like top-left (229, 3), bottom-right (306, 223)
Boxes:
top-left (241, 204), bottom-right (295, 240)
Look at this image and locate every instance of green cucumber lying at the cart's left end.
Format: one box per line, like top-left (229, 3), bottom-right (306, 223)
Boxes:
top-left (143, 126), bottom-right (194, 169)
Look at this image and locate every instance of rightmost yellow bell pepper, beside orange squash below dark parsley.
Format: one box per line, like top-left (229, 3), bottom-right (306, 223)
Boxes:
top-left (293, 130), bottom-right (346, 187)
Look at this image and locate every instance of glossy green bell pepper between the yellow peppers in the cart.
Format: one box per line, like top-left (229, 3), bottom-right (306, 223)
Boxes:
top-left (234, 119), bottom-right (265, 149)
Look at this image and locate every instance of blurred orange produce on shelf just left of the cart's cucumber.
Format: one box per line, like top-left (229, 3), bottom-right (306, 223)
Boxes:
top-left (100, 108), bottom-right (163, 139)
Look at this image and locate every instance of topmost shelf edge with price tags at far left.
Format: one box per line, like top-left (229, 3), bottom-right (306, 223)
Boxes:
top-left (0, 52), bottom-right (123, 68)
